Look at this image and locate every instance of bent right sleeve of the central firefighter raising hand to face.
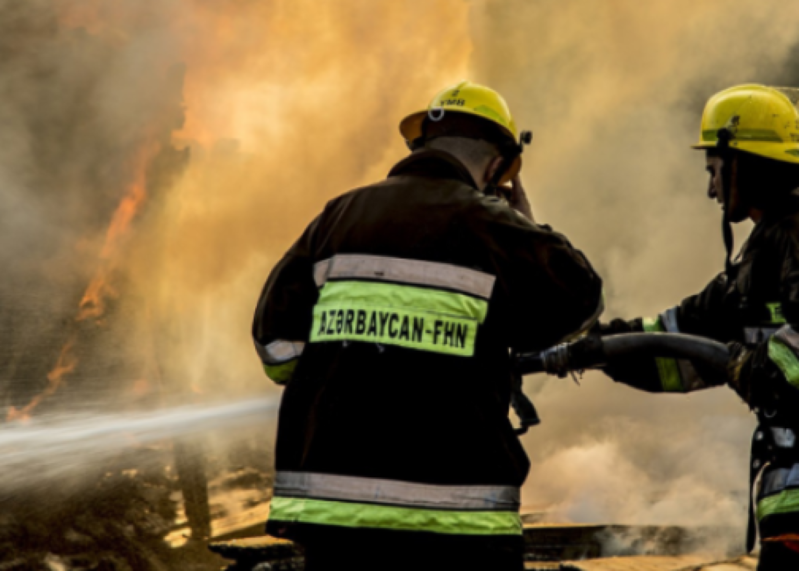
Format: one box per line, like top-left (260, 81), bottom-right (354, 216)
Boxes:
top-left (507, 225), bottom-right (604, 351)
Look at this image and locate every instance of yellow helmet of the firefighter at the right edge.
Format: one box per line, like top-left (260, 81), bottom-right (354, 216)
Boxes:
top-left (693, 84), bottom-right (799, 163)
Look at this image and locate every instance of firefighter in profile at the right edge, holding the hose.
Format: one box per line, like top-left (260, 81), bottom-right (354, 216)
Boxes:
top-left (600, 85), bottom-right (799, 570)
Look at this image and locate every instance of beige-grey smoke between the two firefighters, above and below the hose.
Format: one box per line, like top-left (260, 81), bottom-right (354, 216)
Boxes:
top-left (471, 0), bottom-right (799, 539)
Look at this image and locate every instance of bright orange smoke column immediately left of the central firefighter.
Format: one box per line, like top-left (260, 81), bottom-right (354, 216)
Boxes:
top-left (125, 0), bottom-right (471, 398)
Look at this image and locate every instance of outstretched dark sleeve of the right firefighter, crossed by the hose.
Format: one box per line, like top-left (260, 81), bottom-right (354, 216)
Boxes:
top-left (598, 273), bottom-right (728, 393)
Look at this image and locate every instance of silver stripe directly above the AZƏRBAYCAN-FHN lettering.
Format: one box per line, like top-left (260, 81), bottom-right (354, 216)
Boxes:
top-left (314, 254), bottom-right (496, 299)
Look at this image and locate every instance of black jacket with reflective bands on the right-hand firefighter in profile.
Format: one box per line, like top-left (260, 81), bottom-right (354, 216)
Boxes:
top-left (602, 193), bottom-right (799, 548)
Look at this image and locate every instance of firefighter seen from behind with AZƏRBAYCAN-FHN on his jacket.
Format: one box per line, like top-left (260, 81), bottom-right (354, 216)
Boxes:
top-left (253, 82), bottom-right (602, 571)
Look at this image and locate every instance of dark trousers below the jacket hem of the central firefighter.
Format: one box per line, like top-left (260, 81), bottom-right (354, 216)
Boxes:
top-left (305, 539), bottom-right (524, 571)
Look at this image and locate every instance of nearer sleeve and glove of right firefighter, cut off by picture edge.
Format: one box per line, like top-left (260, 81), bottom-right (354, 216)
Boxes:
top-left (730, 229), bottom-right (799, 418)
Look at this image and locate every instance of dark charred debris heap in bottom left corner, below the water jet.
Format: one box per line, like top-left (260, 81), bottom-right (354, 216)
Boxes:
top-left (0, 449), bottom-right (218, 571)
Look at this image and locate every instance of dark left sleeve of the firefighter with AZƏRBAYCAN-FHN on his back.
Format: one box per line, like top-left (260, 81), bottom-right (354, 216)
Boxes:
top-left (252, 218), bottom-right (319, 385)
